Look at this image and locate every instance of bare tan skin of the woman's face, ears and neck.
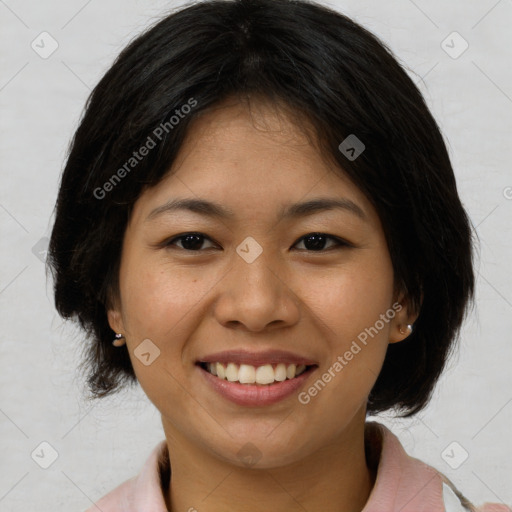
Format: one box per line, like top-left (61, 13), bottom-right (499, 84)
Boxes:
top-left (108, 97), bottom-right (417, 512)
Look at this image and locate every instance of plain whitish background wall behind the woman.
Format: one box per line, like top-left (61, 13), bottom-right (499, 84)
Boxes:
top-left (0, 0), bottom-right (512, 506)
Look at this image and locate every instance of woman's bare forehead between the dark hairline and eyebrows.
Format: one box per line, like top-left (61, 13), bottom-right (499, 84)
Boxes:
top-left (130, 100), bottom-right (373, 227)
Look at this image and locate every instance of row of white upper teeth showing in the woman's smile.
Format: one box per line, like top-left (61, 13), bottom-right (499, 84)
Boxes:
top-left (206, 363), bottom-right (306, 384)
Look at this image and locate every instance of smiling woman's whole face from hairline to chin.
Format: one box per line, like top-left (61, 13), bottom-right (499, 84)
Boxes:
top-left (108, 98), bottom-right (411, 467)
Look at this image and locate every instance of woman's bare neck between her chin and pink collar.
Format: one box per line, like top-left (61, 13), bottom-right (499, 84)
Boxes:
top-left (164, 417), bottom-right (375, 512)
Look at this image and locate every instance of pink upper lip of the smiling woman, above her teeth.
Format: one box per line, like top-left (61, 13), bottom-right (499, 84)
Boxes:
top-left (197, 349), bottom-right (317, 366)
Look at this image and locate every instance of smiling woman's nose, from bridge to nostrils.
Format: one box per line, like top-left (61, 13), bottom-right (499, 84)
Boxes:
top-left (214, 250), bottom-right (300, 332)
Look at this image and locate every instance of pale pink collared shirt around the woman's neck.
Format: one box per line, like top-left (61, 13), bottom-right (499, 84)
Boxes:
top-left (86, 422), bottom-right (512, 512)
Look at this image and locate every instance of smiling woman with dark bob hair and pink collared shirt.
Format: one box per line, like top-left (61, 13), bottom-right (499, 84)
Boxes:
top-left (49, 0), bottom-right (510, 512)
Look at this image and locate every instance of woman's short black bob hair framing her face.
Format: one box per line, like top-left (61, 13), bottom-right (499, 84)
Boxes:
top-left (48, 0), bottom-right (474, 417)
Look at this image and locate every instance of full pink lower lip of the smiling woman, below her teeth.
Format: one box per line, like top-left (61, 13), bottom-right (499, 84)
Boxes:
top-left (197, 366), bottom-right (316, 407)
